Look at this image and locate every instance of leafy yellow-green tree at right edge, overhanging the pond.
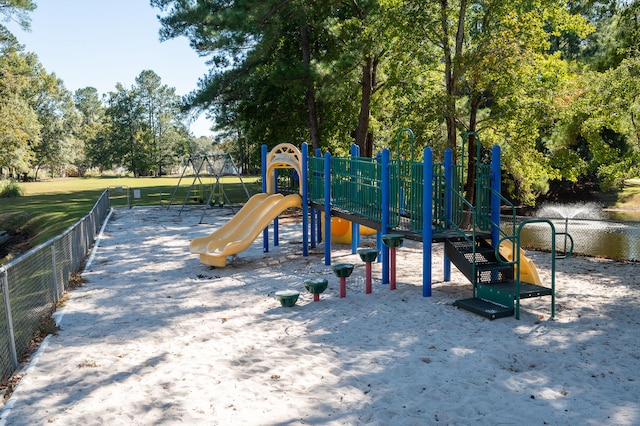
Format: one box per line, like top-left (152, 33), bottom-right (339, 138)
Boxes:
top-left (546, 1), bottom-right (640, 190)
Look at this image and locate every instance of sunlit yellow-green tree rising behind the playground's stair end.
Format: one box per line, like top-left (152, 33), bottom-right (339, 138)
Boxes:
top-left (403, 0), bottom-right (591, 203)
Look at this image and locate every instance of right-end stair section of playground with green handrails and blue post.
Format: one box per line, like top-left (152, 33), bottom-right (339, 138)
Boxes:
top-left (444, 133), bottom-right (573, 320)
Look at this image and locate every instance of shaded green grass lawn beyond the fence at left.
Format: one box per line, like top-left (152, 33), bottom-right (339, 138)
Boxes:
top-left (0, 176), bottom-right (261, 264)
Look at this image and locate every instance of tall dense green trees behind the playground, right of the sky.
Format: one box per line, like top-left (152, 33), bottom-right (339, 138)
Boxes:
top-left (151, 0), bottom-right (640, 204)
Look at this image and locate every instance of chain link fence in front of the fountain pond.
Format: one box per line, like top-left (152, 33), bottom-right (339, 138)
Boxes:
top-left (501, 216), bottom-right (640, 261)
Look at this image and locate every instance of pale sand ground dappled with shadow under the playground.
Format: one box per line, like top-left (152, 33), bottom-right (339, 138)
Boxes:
top-left (0, 208), bottom-right (640, 425)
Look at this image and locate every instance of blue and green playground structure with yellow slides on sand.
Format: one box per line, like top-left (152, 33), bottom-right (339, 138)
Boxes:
top-left (190, 135), bottom-right (559, 319)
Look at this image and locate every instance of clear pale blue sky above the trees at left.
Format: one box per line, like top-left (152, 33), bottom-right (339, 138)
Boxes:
top-left (7, 0), bottom-right (213, 136)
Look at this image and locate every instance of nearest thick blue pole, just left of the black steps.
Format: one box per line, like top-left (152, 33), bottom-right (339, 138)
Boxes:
top-left (422, 147), bottom-right (433, 297)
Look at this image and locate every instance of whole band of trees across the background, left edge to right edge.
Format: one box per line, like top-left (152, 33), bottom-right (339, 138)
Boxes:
top-left (0, 0), bottom-right (640, 204)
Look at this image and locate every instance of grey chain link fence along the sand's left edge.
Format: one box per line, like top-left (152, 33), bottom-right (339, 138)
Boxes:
top-left (0, 190), bottom-right (110, 378)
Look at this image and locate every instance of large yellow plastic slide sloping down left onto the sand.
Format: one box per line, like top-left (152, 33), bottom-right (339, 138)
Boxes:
top-left (189, 193), bottom-right (302, 268)
